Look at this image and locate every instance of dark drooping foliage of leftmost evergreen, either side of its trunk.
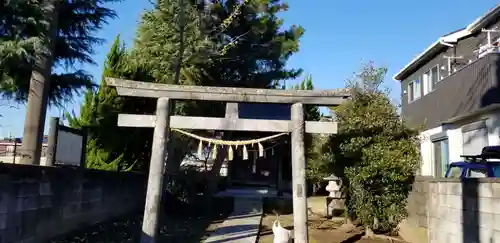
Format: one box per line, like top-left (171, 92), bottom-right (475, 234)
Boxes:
top-left (0, 0), bottom-right (120, 105)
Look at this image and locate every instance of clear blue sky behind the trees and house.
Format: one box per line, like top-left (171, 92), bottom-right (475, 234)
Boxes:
top-left (0, 0), bottom-right (498, 137)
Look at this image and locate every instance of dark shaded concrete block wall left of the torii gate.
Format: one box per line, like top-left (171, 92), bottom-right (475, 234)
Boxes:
top-left (0, 164), bottom-right (146, 243)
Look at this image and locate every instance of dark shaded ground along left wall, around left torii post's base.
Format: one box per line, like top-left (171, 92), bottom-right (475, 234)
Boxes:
top-left (49, 196), bottom-right (232, 243)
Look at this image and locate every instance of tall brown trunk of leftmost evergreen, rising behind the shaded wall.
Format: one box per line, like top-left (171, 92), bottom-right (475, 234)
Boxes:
top-left (20, 0), bottom-right (60, 164)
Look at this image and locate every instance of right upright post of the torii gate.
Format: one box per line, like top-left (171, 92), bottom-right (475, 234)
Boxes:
top-left (291, 103), bottom-right (309, 243)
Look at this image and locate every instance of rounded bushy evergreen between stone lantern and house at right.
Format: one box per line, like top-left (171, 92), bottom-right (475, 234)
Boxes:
top-left (324, 63), bottom-right (420, 235)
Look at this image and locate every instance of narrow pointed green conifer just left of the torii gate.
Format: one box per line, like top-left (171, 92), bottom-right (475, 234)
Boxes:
top-left (66, 36), bottom-right (134, 170)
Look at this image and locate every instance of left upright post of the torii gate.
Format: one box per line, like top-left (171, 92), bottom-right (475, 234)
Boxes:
top-left (141, 97), bottom-right (171, 243)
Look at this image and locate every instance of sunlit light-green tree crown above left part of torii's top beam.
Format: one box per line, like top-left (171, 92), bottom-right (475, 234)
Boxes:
top-left (131, 0), bottom-right (211, 85)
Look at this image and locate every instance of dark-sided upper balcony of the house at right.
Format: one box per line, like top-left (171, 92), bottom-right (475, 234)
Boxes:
top-left (402, 53), bottom-right (500, 129)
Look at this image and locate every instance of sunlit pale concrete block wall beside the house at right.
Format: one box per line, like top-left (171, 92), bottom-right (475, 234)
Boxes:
top-left (407, 177), bottom-right (500, 243)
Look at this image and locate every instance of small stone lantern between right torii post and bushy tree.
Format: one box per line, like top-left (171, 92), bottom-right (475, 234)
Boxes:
top-left (323, 175), bottom-right (344, 217)
